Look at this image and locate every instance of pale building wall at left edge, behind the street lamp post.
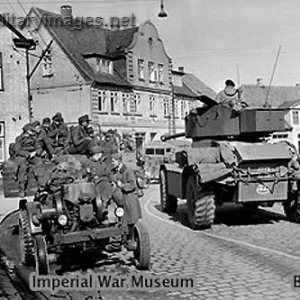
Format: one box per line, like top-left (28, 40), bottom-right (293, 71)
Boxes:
top-left (0, 26), bottom-right (29, 163)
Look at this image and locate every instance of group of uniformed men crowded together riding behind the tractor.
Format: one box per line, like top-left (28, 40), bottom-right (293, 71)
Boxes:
top-left (9, 112), bottom-right (124, 197)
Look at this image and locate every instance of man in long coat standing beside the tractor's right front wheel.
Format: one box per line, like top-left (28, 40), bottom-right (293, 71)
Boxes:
top-left (111, 153), bottom-right (142, 250)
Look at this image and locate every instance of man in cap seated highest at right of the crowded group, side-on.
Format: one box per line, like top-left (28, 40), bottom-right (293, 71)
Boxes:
top-left (69, 115), bottom-right (94, 156)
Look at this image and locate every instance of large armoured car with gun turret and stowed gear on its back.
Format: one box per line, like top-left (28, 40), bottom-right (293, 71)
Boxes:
top-left (159, 96), bottom-right (300, 229)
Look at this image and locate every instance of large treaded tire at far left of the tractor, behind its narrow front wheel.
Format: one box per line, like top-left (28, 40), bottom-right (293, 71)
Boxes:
top-left (19, 210), bottom-right (34, 266)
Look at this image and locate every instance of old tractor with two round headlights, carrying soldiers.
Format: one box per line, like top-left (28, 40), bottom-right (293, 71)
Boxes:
top-left (19, 161), bottom-right (150, 275)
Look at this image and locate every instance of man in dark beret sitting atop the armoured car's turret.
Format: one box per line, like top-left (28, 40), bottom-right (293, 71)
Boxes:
top-left (215, 79), bottom-right (246, 110)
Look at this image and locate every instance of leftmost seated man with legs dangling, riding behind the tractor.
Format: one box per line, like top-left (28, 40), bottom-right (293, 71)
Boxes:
top-left (15, 124), bottom-right (43, 197)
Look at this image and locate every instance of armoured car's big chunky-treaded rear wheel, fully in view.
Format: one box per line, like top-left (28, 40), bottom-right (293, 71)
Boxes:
top-left (186, 176), bottom-right (216, 229)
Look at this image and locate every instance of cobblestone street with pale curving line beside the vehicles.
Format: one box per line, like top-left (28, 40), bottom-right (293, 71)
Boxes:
top-left (0, 185), bottom-right (300, 300)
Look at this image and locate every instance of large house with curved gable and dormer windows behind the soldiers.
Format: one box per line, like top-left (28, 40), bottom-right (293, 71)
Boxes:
top-left (23, 6), bottom-right (215, 147)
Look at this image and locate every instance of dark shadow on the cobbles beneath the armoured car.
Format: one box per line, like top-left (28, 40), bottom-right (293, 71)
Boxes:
top-left (154, 203), bottom-right (286, 227)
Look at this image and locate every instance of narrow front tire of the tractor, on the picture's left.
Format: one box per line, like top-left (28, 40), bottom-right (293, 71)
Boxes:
top-left (35, 235), bottom-right (50, 275)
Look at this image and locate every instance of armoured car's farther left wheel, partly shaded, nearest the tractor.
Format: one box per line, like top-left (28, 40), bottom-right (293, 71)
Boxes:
top-left (159, 170), bottom-right (177, 213)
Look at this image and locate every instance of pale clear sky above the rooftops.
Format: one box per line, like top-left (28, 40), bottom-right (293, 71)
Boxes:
top-left (0, 0), bottom-right (300, 92)
